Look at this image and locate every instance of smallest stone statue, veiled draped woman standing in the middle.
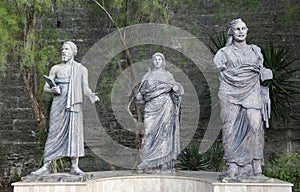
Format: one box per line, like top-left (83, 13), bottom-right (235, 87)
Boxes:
top-left (136, 53), bottom-right (184, 173)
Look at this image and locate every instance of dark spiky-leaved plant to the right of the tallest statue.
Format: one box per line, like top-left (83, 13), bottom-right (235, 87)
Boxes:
top-left (262, 45), bottom-right (300, 120)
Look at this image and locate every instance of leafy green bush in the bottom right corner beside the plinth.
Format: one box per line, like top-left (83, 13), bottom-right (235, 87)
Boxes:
top-left (263, 151), bottom-right (300, 192)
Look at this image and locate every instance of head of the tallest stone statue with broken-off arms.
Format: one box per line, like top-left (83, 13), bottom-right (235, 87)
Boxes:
top-left (226, 18), bottom-right (248, 46)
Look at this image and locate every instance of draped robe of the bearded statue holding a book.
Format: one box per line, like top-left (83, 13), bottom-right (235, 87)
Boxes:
top-left (44, 61), bottom-right (84, 163)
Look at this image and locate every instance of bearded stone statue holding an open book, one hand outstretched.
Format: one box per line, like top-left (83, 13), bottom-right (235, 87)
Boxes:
top-left (31, 41), bottom-right (99, 175)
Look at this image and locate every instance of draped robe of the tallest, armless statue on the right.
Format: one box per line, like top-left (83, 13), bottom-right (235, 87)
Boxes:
top-left (214, 45), bottom-right (270, 166)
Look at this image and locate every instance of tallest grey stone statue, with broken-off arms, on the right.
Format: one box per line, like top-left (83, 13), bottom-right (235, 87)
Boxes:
top-left (214, 19), bottom-right (273, 182)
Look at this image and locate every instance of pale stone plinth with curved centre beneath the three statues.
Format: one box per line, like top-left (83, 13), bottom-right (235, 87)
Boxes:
top-left (13, 171), bottom-right (292, 192)
